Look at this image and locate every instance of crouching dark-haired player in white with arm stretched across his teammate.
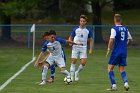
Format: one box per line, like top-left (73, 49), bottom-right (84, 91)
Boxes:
top-left (34, 31), bottom-right (81, 85)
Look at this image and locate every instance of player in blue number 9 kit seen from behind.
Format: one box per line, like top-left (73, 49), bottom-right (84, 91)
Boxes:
top-left (106, 14), bottom-right (132, 91)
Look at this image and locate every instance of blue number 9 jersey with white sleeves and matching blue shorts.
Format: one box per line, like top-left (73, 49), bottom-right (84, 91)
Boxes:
top-left (108, 25), bottom-right (132, 66)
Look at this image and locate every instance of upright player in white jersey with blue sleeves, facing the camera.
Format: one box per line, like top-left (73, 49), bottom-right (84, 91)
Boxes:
top-left (69, 15), bottom-right (93, 81)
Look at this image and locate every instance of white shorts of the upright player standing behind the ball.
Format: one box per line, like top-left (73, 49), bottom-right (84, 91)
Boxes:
top-left (71, 46), bottom-right (87, 59)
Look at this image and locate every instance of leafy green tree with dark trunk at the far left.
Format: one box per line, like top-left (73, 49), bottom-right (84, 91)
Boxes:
top-left (0, 0), bottom-right (39, 41)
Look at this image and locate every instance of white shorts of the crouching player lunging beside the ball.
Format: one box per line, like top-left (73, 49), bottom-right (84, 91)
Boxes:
top-left (46, 55), bottom-right (66, 68)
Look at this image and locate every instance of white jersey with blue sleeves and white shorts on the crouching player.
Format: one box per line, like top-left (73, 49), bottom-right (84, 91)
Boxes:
top-left (42, 38), bottom-right (66, 67)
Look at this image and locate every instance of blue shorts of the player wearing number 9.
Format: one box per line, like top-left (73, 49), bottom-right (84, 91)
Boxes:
top-left (108, 56), bottom-right (127, 66)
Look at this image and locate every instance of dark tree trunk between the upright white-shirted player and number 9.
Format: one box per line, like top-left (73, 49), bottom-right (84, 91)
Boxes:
top-left (92, 0), bottom-right (103, 43)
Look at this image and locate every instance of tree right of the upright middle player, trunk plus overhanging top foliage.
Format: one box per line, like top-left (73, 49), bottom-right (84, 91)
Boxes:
top-left (91, 0), bottom-right (112, 43)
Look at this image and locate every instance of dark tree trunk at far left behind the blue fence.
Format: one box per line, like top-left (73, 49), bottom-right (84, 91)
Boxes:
top-left (1, 15), bottom-right (12, 41)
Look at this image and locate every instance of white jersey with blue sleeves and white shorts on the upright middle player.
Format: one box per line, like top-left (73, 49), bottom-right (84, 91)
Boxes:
top-left (70, 27), bottom-right (92, 59)
